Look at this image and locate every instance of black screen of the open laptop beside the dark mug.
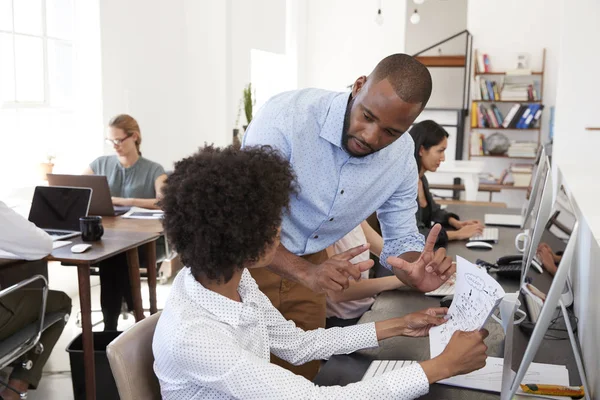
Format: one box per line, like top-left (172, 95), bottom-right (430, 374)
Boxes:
top-left (29, 186), bottom-right (92, 231)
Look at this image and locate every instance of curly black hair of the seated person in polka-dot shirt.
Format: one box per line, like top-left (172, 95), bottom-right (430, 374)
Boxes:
top-left (161, 145), bottom-right (296, 283)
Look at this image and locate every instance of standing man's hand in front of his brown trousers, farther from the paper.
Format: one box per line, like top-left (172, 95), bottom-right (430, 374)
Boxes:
top-left (306, 243), bottom-right (374, 293)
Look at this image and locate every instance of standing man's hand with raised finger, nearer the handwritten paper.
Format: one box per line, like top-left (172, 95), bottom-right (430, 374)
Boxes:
top-left (387, 224), bottom-right (456, 293)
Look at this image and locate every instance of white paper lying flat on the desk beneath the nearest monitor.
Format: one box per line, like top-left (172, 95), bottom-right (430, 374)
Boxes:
top-left (438, 357), bottom-right (569, 399)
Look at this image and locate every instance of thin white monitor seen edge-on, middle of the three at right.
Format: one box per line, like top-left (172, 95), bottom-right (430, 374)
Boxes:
top-left (521, 157), bottom-right (553, 287)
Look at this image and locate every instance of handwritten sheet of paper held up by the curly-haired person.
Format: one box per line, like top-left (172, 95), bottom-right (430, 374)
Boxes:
top-left (429, 257), bottom-right (505, 358)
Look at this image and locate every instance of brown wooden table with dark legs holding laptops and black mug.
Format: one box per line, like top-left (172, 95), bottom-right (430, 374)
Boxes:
top-left (48, 229), bottom-right (160, 400)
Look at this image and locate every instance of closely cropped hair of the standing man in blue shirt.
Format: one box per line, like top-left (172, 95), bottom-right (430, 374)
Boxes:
top-left (369, 53), bottom-right (432, 108)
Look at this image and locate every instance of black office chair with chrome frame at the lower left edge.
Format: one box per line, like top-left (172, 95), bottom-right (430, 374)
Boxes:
top-left (0, 275), bottom-right (69, 399)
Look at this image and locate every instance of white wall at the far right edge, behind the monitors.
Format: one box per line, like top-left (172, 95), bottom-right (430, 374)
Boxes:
top-left (553, 0), bottom-right (600, 398)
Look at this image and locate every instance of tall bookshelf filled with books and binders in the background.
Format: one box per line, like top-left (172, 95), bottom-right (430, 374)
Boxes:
top-left (467, 49), bottom-right (546, 190)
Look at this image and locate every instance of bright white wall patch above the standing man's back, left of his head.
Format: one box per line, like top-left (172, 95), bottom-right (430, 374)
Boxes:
top-left (298, 0), bottom-right (406, 91)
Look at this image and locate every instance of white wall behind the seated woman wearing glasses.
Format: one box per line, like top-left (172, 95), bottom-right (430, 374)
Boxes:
top-left (98, 0), bottom-right (286, 169)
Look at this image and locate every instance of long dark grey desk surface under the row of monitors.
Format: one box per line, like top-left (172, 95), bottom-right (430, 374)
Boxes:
top-left (314, 206), bottom-right (580, 400)
